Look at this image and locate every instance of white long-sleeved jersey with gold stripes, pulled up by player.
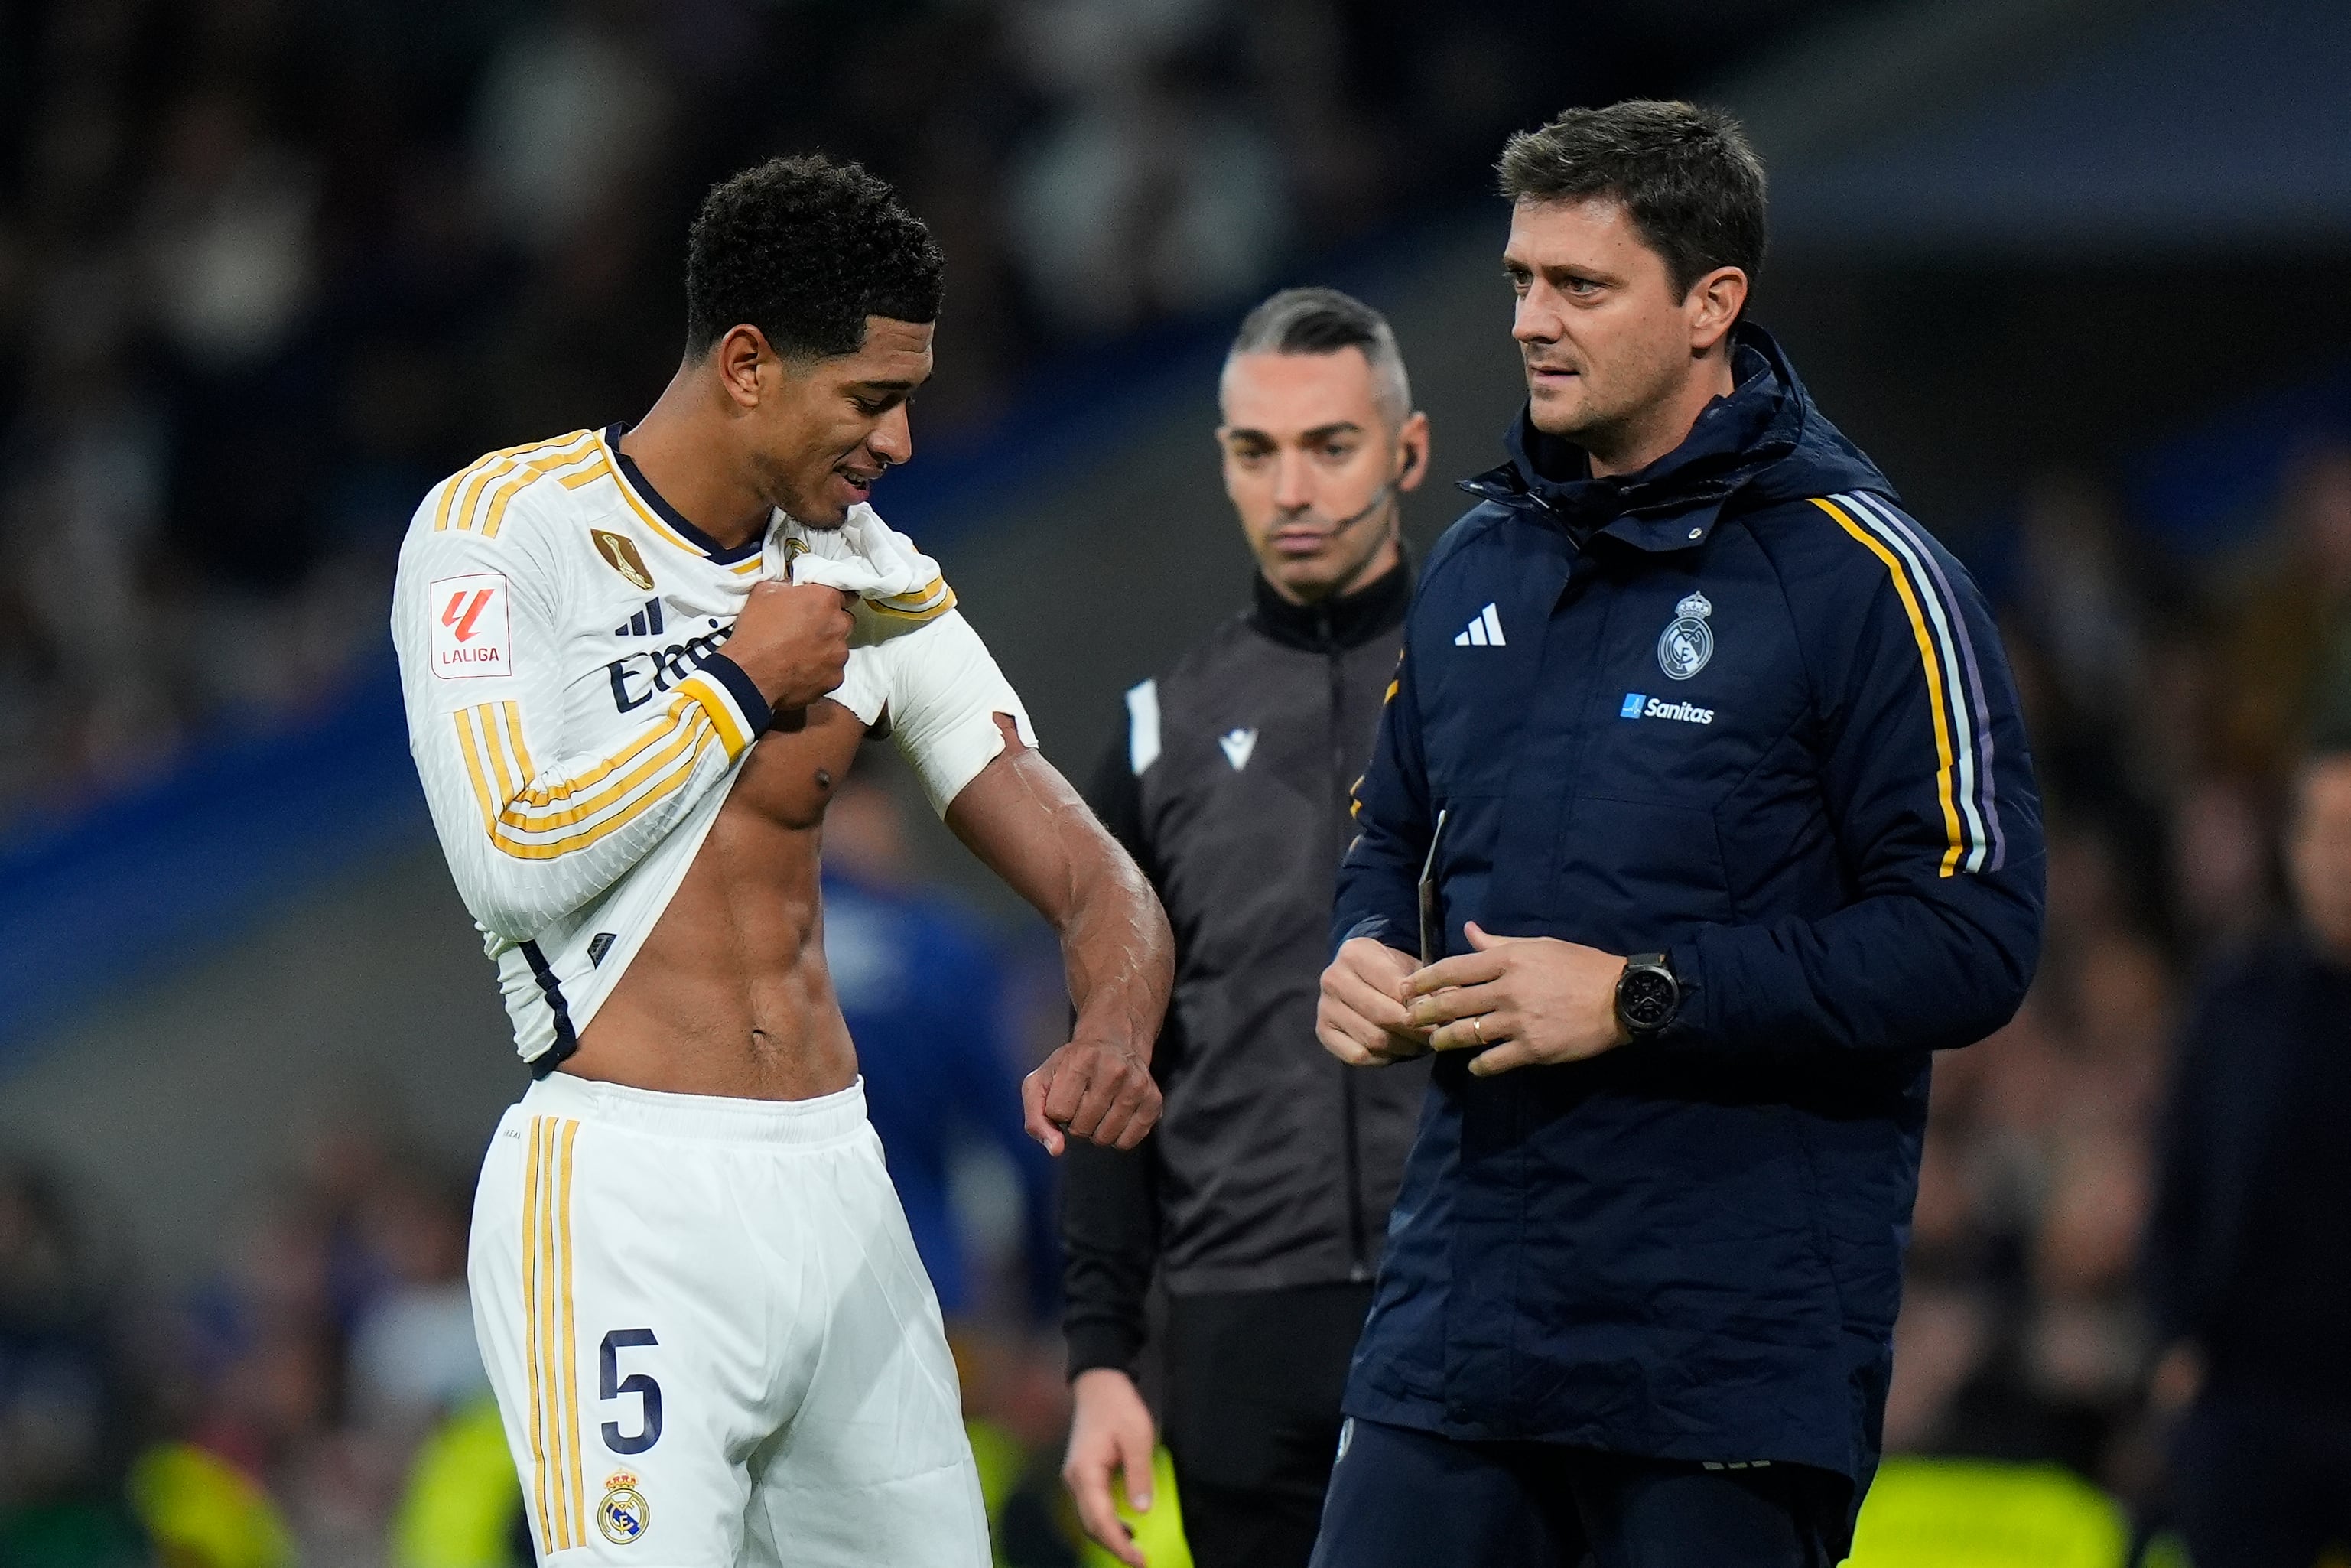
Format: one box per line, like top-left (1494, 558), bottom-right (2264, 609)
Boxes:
top-left (392, 425), bottom-right (1035, 1060)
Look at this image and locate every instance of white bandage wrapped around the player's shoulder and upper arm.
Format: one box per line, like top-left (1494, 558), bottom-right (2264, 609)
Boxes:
top-left (860, 609), bottom-right (1037, 815)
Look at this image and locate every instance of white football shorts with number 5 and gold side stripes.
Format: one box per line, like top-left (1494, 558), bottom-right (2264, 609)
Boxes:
top-left (468, 1072), bottom-right (990, 1568)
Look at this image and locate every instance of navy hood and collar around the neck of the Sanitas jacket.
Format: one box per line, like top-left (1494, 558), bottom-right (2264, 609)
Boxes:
top-left (1462, 322), bottom-right (1893, 550)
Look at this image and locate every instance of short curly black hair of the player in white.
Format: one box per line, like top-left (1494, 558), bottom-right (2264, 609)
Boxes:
top-left (687, 155), bottom-right (945, 359)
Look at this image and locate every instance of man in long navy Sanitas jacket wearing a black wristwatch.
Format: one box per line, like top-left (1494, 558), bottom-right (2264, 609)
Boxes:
top-left (1314, 103), bottom-right (2043, 1568)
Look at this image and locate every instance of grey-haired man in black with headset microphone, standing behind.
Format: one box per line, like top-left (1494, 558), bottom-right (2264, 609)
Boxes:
top-left (1062, 289), bottom-right (1429, 1568)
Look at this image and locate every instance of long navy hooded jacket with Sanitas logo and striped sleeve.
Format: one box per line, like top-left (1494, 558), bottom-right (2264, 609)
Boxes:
top-left (1333, 327), bottom-right (2043, 1532)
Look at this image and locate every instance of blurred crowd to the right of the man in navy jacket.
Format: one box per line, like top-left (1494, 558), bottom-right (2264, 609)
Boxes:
top-left (1885, 441), bottom-right (2351, 1498)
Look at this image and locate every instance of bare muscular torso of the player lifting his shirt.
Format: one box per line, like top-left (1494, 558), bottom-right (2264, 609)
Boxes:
top-left (564, 698), bottom-right (865, 1100)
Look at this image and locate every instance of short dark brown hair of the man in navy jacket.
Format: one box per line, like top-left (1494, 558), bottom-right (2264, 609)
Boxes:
top-left (1495, 99), bottom-right (1766, 305)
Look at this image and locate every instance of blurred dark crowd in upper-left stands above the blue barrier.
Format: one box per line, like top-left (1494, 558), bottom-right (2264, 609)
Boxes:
top-left (0, 0), bottom-right (1655, 813)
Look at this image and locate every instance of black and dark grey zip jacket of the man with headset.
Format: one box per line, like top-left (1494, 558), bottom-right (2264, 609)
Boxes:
top-left (1062, 567), bottom-right (1427, 1375)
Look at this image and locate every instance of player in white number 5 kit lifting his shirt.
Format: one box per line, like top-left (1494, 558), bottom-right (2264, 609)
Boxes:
top-left (392, 158), bottom-right (1171, 1568)
